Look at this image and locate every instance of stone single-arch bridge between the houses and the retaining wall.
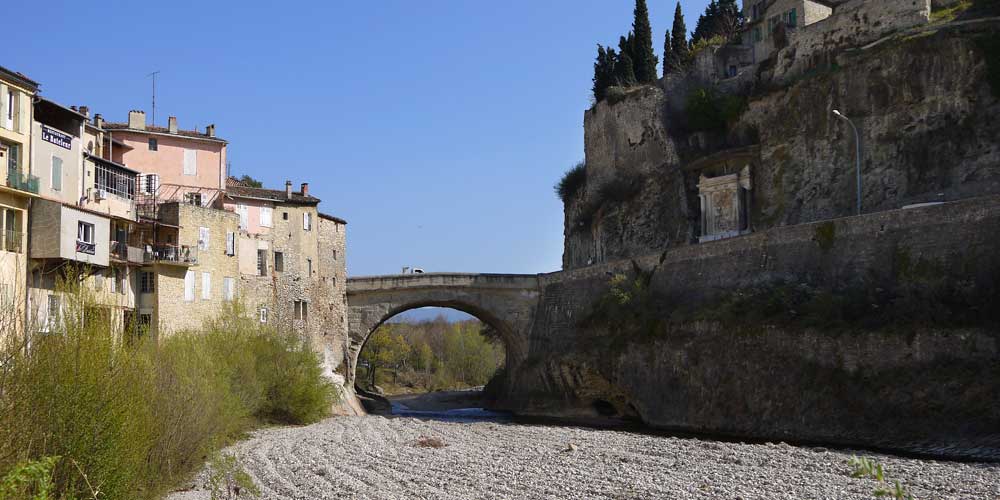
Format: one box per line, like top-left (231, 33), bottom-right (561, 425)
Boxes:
top-left (347, 273), bottom-right (541, 387)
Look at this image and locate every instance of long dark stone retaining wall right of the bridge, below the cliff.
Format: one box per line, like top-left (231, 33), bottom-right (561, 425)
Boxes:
top-left (508, 196), bottom-right (1000, 453)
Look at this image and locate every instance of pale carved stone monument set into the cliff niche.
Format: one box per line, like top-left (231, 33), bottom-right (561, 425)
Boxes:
top-left (698, 165), bottom-right (751, 243)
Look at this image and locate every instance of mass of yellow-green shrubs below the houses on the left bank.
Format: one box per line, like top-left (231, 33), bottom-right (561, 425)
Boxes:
top-left (0, 280), bottom-right (334, 499)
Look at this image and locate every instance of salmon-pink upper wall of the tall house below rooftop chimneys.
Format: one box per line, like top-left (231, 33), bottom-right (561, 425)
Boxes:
top-left (112, 130), bottom-right (226, 190)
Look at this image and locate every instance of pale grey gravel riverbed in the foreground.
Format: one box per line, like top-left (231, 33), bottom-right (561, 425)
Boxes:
top-left (168, 416), bottom-right (1000, 500)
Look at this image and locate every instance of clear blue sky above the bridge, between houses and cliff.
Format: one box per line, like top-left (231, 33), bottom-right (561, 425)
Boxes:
top-left (7, 0), bottom-right (708, 275)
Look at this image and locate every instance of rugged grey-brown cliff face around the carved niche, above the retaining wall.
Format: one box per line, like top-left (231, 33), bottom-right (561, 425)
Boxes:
top-left (563, 24), bottom-right (1000, 269)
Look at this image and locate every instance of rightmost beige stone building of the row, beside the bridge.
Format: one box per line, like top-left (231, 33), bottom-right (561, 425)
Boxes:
top-left (224, 179), bottom-right (347, 368)
